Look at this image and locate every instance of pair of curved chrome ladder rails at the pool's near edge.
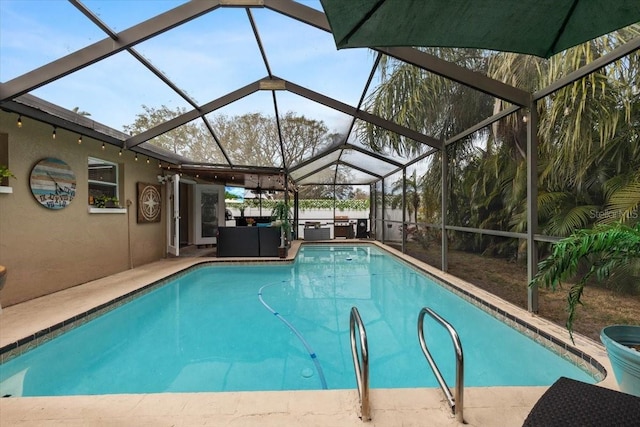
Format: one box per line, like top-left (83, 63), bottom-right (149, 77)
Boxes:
top-left (349, 307), bottom-right (464, 424)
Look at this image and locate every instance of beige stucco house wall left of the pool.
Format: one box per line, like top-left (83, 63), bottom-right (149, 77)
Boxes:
top-left (0, 111), bottom-right (166, 307)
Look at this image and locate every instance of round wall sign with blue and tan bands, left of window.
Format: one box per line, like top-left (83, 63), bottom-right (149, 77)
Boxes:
top-left (29, 157), bottom-right (76, 209)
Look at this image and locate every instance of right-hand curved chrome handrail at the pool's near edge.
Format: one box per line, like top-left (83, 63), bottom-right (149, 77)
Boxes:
top-left (418, 307), bottom-right (464, 423)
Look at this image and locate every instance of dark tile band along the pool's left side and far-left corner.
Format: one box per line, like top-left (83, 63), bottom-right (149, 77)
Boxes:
top-left (0, 259), bottom-right (294, 364)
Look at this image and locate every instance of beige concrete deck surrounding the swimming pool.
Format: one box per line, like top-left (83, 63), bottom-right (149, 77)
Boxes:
top-left (0, 241), bottom-right (618, 427)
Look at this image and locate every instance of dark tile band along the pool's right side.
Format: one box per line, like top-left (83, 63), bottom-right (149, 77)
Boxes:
top-left (377, 245), bottom-right (607, 382)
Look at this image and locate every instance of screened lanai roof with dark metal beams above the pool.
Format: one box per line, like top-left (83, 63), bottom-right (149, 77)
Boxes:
top-left (0, 0), bottom-right (640, 188)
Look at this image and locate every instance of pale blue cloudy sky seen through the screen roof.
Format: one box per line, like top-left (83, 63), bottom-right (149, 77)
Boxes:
top-left (0, 0), bottom-right (374, 131)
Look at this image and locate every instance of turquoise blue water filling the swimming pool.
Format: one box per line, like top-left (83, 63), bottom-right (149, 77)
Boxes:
top-left (0, 245), bottom-right (595, 396)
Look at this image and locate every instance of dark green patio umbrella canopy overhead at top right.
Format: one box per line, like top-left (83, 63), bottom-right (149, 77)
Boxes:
top-left (321, 0), bottom-right (640, 58)
